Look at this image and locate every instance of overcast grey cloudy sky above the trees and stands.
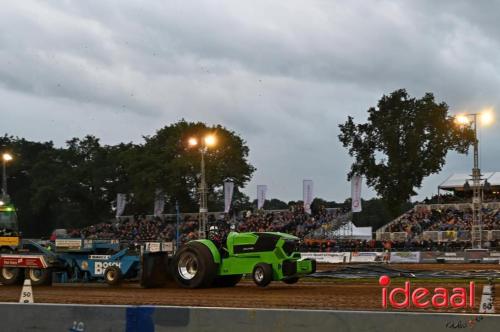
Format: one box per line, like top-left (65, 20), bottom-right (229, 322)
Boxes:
top-left (0, 0), bottom-right (500, 200)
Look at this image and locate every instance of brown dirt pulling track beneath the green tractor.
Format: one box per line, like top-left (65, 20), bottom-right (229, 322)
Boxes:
top-left (0, 264), bottom-right (500, 312)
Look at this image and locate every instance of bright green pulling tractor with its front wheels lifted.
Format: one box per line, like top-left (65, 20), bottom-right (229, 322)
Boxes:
top-left (171, 232), bottom-right (316, 288)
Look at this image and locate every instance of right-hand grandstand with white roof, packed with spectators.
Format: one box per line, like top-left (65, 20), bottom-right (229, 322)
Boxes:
top-left (376, 172), bottom-right (500, 247)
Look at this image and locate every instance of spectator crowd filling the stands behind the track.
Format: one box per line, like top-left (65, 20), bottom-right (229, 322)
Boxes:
top-left (62, 196), bottom-right (500, 252)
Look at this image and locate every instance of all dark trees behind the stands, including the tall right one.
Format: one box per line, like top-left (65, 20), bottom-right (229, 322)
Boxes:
top-left (0, 89), bottom-right (474, 236)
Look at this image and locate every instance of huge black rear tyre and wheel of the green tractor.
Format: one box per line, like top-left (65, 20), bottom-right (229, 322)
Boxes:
top-left (172, 242), bottom-right (217, 288)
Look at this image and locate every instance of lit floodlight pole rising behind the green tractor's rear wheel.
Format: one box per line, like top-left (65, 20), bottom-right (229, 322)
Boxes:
top-left (188, 135), bottom-right (216, 239)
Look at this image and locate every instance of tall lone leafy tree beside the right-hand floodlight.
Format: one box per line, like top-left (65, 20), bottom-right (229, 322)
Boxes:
top-left (338, 89), bottom-right (473, 215)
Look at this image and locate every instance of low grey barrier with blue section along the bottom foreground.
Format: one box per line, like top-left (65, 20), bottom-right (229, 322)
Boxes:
top-left (0, 303), bottom-right (500, 332)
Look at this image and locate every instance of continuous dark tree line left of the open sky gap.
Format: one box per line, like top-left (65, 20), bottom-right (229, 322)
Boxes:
top-left (0, 120), bottom-right (255, 236)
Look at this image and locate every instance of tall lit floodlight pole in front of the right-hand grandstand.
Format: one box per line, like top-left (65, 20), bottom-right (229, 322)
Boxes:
top-left (455, 110), bottom-right (493, 249)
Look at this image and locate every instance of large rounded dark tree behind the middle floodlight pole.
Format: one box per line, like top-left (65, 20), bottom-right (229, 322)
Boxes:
top-left (116, 120), bottom-right (255, 212)
